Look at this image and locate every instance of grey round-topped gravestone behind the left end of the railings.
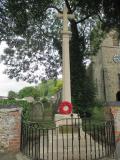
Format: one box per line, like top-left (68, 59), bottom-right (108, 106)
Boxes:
top-left (30, 102), bottom-right (44, 122)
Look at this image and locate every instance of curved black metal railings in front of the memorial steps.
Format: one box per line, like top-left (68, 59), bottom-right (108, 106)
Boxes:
top-left (21, 116), bottom-right (115, 160)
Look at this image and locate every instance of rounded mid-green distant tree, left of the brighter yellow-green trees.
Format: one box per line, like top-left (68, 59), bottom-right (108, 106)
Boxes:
top-left (18, 87), bottom-right (39, 98)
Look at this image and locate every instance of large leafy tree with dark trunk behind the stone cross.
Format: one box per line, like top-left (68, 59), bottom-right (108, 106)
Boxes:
top-left (0, 0), bottom-right (119, 109)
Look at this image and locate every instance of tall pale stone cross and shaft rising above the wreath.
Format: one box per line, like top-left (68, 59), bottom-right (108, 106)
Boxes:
top-left (58, 7), bottom-right (74, 102)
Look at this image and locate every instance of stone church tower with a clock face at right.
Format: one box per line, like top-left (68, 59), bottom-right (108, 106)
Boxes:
top-left (91, 30), bottom-right (120, 102)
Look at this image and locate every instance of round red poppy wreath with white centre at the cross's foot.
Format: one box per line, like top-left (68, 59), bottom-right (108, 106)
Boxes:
top-left (59, 101), bottom-right (72, 114)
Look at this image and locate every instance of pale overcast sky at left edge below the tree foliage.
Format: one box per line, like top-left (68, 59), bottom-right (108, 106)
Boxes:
top-left (0, 42), bottom-right (34, 96)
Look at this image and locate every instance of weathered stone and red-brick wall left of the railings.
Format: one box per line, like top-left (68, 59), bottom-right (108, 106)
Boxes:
top-left (0, 106), bottom-right (21, 152)
